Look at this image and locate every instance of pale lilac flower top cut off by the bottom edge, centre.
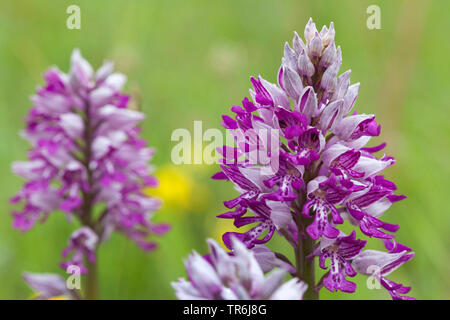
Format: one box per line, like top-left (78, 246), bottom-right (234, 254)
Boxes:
top-left (172, 239), bottom-right (306, 300)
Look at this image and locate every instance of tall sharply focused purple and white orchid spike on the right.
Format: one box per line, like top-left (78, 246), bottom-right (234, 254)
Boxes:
top-left (201, 20), bottom-right (414, 299)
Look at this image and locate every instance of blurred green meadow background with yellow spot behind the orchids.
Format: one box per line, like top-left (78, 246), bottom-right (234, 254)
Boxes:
top-left (0, 0), bottom-right (450, 299)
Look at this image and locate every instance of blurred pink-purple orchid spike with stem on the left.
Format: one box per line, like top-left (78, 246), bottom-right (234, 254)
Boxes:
top-left (11, 50), bottom-right (169, 298)
